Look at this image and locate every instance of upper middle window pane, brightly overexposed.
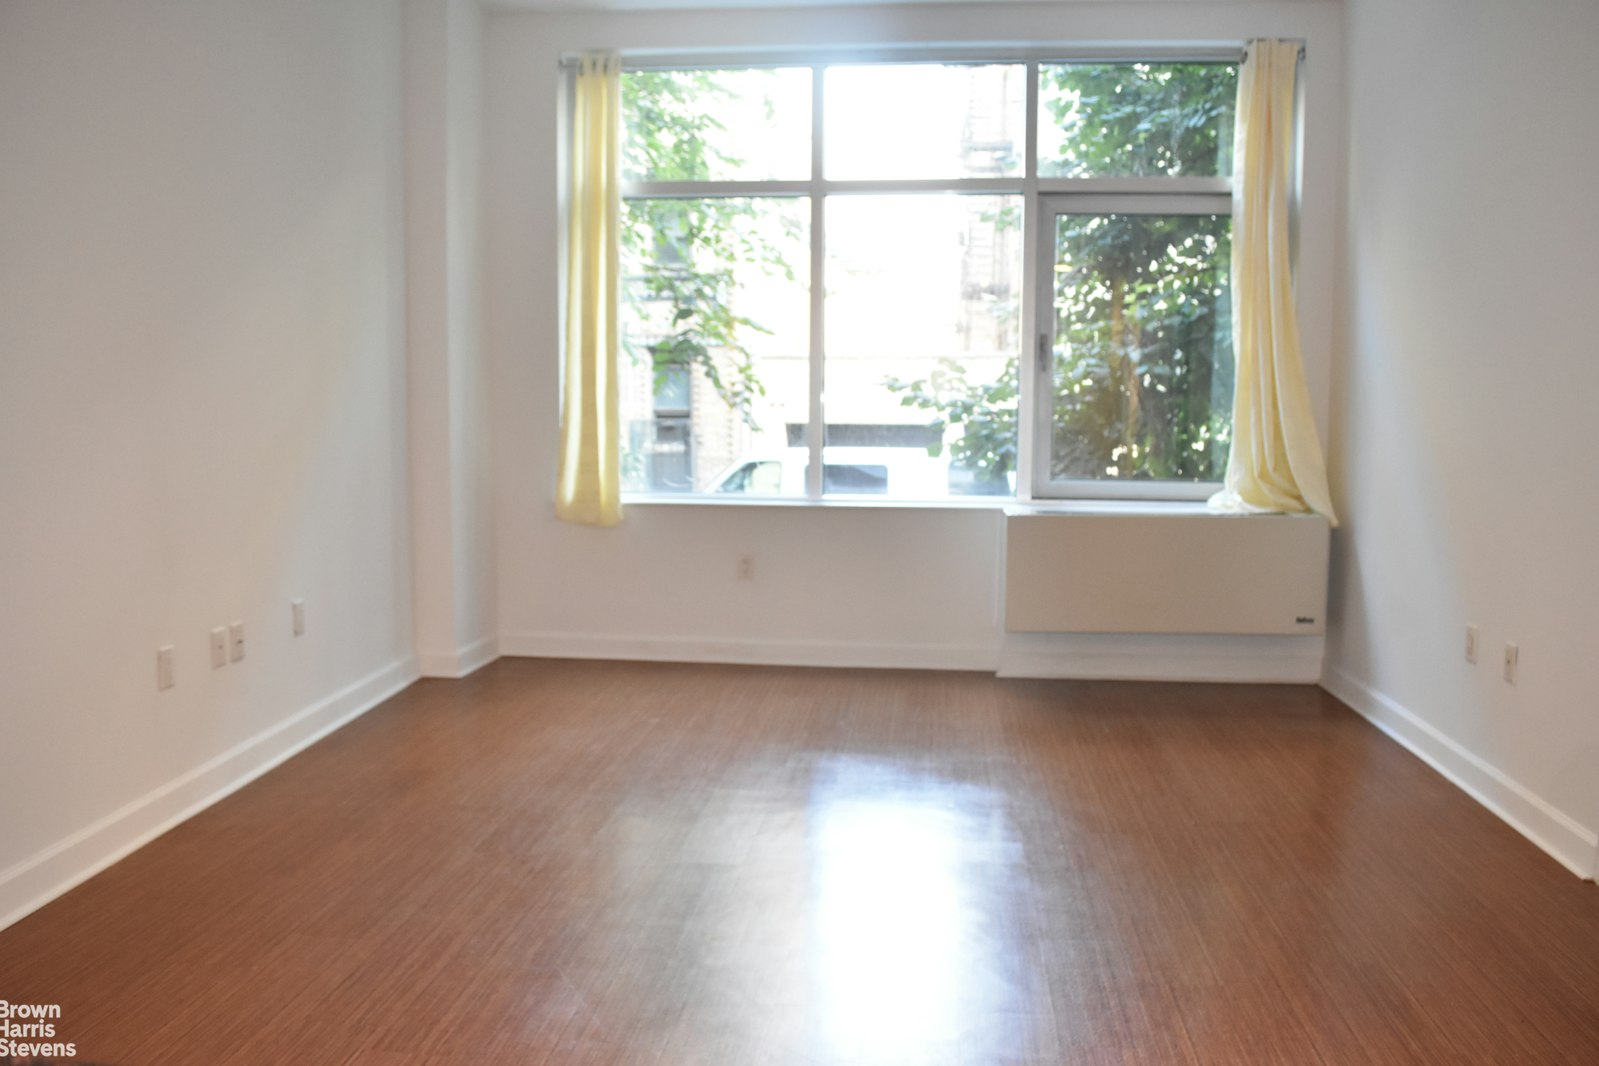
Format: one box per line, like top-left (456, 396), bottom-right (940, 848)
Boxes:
top-left (822, 64), bottom-right (1027, 181)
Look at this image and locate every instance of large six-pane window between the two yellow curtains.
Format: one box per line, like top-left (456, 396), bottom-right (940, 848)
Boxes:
top-left (620, 61), bottom-right (1236, 499)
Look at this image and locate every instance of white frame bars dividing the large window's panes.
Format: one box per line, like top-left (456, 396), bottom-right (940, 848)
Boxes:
top-left (620, 42), bottom-right (1244, 507)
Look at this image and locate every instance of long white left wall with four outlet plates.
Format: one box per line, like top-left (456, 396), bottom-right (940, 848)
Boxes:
top-left (0, 0), bottom-right (413, 924)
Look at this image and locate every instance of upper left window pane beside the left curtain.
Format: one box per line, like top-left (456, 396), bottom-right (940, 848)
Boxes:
top-left (622, 67), bottom-right (811, 181)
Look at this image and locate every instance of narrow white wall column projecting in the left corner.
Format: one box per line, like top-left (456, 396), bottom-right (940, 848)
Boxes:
top-left (405, 0), bottom-right (497, 678)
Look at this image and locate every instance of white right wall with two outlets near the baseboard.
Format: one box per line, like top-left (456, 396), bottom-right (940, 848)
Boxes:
top-left (1327, 0), bottom-right (1599, 874)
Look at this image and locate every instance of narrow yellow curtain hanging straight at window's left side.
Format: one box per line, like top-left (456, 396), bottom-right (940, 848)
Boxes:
top-left (555, 53), bottom-right (622, 526)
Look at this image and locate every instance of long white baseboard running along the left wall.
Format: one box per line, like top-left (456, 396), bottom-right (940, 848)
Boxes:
top-left (0, 657), bottom-right (417, 929)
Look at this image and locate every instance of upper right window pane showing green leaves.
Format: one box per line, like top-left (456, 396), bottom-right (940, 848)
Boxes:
top-left (1038, 62), bottom-right (1238, 177)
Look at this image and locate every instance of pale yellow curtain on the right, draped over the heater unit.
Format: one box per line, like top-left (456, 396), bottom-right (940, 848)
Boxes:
top-left (1210, 40), bottom-right (1338, 526)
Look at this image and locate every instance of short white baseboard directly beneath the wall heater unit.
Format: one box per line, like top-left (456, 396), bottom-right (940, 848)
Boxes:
top-left (995, 633), bottom-right (1322, 684)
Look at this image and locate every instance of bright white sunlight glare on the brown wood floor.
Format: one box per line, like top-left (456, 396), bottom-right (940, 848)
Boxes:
top-left (809, 759), bottom-right (1014, 1064)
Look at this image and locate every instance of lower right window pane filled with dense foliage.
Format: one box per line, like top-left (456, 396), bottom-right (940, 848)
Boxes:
top-left (1049, 214), bottom-right (1233, 481)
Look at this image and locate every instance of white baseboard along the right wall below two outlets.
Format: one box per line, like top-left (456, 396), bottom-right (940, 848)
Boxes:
top-left (1322, 666), bottom-right (1599, 881)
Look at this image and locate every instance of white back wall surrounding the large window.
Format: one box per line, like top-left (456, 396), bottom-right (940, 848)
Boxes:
top-left (484, 0), bottom-right (1343, 679)
